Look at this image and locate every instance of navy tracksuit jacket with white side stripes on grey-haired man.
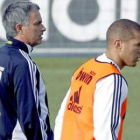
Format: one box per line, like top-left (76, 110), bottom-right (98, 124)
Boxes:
top-left (0, 39), bottom-right (53, 140)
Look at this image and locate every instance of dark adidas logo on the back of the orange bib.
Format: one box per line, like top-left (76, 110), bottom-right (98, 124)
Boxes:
top-left (67, 86), bottom-right (83, 114)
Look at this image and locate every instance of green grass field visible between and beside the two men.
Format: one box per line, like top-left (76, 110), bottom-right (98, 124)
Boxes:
top-left (33, 57), bottom-right (140, 140)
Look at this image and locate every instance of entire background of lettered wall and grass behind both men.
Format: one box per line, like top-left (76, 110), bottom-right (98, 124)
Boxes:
top-left (0, 0), bottom-right (140, 140)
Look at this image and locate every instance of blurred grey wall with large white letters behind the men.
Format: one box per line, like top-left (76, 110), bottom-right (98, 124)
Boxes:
top-left (0, 0), bottom-right (140, 56)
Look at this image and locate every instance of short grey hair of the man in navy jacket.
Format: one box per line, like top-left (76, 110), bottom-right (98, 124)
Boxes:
top-left (2, 1), bottom-right (40, 38)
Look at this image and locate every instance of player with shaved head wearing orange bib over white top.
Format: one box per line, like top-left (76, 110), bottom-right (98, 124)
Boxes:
top-left (54, 19), bottom-right (140, 140)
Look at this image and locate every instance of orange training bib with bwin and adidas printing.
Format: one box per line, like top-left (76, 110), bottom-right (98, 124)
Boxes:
top-left (61, 59), bottom-right (127, 140)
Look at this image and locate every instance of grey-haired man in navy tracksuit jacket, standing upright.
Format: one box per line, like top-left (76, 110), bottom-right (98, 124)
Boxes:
top-left (0, 1), bottom-right (53, 140)
